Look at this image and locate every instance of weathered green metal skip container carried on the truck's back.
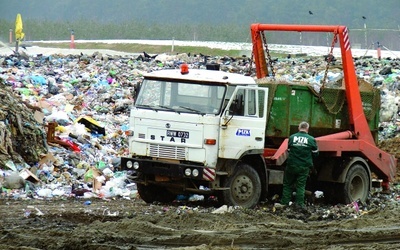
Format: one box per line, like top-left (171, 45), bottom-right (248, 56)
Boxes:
top-left (258, 80), bottom-right (380, 148)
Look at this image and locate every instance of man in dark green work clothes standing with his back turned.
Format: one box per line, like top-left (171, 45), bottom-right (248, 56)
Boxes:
top-left (280, 122), bottom-right (318, 209)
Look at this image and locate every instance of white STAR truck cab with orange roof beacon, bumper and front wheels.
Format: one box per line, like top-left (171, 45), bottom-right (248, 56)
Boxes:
top-left (121, 64), bottom-right (268, 207)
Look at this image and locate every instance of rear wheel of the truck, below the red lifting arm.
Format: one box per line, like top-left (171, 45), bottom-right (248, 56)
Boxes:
top-left (342, 164), bottom-right (370, 204)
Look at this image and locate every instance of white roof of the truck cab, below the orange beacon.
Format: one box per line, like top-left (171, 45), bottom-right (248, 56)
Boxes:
top-left (144, 69), bottom-right (256, 85)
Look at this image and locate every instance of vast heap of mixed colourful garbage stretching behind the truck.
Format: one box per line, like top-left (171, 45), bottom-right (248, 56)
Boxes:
top-left (0, 48), bottom-right (400, 207)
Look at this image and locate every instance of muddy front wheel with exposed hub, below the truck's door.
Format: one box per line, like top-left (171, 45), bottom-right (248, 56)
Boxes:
top-left (222, 164), bottom-right (261, 208)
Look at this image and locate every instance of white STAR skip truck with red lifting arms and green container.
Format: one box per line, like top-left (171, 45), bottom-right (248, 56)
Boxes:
top-left (121, 24), bottom-right (397, 208)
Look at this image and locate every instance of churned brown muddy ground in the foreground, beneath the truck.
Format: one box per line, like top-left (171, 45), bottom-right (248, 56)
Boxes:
top-left (0, 188), bottom-right (400, 250)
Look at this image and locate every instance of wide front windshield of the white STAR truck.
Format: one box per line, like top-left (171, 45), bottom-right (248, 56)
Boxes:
top-left (135, 79), bottom-right (226, 115)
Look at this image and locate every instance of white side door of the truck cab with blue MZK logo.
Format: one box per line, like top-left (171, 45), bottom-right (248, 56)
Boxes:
top-left (219, 87), bottom-right (268, 159)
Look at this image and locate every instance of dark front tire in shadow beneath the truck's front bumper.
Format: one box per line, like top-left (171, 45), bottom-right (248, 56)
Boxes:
top-left (137, 184), bottom-right (176, 203)
